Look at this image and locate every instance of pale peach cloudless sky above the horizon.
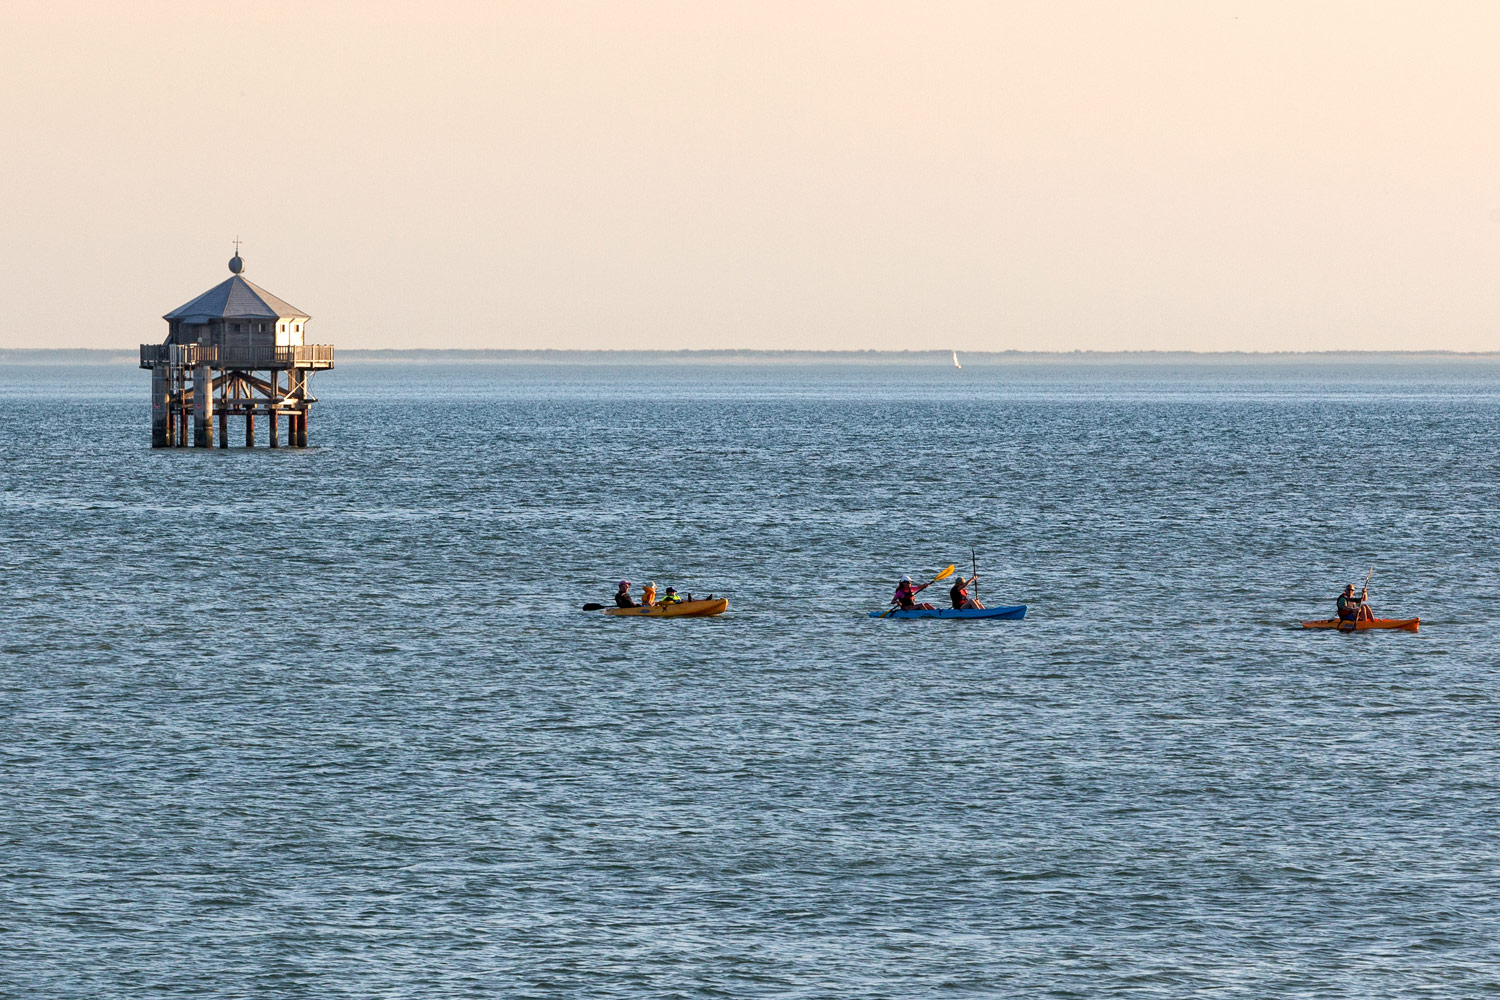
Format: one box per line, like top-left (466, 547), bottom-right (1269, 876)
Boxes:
top-left (0, 0), bottom-right (1500, 351)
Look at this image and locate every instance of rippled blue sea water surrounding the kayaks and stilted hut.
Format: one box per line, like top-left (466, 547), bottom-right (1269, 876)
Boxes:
top-left (0, 358), bottom-right (1500, 999)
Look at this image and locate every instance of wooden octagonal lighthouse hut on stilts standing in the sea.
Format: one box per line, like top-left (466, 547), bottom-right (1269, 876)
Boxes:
top-left (141, 247), bottom-right (333, 448)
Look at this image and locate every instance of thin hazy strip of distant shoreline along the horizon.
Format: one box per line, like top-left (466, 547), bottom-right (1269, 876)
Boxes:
top-left (0, 348), bottom-right (1500, 366)
